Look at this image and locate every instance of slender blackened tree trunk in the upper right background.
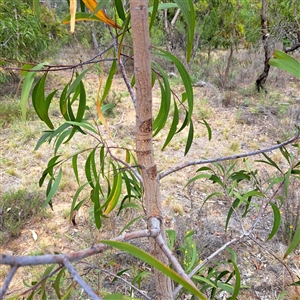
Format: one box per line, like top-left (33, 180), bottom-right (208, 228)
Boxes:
top-left (256, 0), bottom-right (271, 91)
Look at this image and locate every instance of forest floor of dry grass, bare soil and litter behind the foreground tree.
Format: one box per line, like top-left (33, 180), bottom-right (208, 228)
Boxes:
top-left (0, 48), bottom-right (300, 300)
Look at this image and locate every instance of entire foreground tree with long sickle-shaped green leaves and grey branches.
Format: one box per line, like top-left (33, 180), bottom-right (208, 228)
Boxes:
top-left (0, 0), bottom-right (300, 300)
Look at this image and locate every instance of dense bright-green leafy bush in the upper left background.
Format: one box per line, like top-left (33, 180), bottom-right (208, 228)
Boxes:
top-left (0, 0), bottom-right (67, 64)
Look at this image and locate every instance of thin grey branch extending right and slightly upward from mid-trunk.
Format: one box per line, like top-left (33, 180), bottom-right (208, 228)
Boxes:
top-left (159, 130), bottom-right (300, 179)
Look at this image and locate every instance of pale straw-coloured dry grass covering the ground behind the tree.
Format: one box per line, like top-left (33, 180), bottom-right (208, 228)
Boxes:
top-left (0, 47), bottom-right (299, 299)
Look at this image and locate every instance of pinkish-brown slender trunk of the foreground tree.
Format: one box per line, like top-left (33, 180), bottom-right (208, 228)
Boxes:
top-left (130, 0), bottom-right (173, 300)
